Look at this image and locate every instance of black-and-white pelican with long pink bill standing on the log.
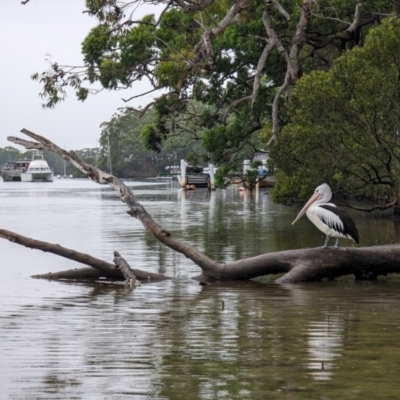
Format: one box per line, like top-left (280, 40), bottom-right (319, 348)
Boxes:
top-left (292, 183), bottom-right (359, 249)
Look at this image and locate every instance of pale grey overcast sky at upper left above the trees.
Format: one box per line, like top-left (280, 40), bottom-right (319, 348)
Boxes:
top-left (0, 0), bottom-right (161, 150)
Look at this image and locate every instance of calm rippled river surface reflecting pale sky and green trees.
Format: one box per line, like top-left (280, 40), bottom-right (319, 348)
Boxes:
top-left (0, 179), bottom-right (400, 400)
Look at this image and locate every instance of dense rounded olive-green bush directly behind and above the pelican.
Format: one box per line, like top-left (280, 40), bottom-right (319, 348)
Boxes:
top-left (271, 19), bottom-right (400, 206)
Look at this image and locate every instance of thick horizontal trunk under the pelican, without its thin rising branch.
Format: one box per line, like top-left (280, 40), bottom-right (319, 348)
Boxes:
top-left (191, 245), bottom-right (400, 284)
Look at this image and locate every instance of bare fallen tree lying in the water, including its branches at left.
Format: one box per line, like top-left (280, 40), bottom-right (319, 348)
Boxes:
top-left (0, 129), bottom-right (400, 283)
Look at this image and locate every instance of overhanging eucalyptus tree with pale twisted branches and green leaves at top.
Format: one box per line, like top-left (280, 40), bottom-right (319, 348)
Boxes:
top-left (28, 0), bottom-right (399, 170)
